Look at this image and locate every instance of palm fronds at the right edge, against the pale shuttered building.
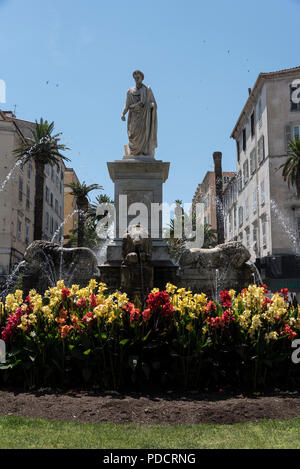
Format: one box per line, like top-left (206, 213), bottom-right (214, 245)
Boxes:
top-left (279, 137), bottom-right (300, 198)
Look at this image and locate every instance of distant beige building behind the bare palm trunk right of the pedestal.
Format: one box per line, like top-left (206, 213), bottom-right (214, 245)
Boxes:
top-left (193, 171), bottom-right (236, 230)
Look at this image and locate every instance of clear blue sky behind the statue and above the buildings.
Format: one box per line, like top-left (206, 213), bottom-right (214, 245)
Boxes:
top-left (0, 0), bottom-right (300, 202)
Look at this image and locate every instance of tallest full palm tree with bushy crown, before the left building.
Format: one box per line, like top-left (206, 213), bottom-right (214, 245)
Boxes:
top-left (14, 118), bottom-right (70, 240)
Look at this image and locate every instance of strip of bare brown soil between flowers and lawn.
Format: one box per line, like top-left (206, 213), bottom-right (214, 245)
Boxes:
top-left (0, 389), bottom-right (300, 425)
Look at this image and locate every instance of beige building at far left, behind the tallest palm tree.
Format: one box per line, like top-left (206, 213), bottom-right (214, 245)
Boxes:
top-left (0, 111), bottom-right (64, 279)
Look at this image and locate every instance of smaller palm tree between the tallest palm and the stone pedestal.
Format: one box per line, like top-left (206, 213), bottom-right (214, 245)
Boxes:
top-left (65, 181), bottom-right (103, 247)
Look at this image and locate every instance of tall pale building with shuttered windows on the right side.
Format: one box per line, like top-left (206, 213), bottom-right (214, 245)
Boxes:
top-left (224, 67), bottom-right (300, 289)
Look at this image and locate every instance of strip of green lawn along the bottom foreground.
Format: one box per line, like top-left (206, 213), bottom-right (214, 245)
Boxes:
top-left (0, 416), bottom-right (300, 449)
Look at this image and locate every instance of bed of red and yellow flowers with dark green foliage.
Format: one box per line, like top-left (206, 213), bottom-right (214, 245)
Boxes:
top-left (0, 280), bottom-right (300, 390)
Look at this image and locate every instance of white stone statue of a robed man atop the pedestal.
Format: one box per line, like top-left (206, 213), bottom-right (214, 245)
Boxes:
top-left (121, 70), bottom-right (157, 157)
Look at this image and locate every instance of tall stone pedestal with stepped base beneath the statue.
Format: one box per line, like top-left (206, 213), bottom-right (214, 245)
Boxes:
top-left (100, 156), bottom-right (178, 295)
